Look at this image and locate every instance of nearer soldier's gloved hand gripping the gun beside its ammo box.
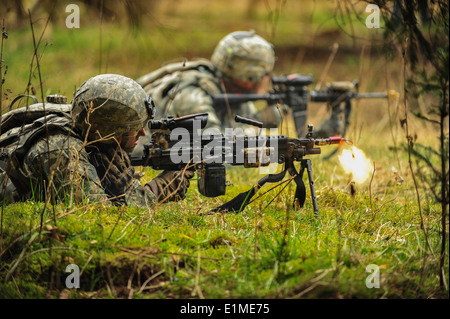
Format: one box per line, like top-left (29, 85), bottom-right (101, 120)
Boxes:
top-left (145, 170), bottom-right (195, 202)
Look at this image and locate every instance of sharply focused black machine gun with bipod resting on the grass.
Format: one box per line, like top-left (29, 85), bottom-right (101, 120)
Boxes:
top-left (131, 113), bottom-right (345, 215)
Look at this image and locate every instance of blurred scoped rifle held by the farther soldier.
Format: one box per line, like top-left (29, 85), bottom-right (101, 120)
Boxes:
top-left (212, 74), bottom-right (390, 137)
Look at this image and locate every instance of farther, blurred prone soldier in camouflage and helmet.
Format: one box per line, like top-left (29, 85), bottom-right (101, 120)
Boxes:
top-left (133, 31), bottom-right (287, 155)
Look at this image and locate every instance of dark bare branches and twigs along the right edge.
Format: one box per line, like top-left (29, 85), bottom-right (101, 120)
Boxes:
top-left (375, 0), bottom-right (450, 289)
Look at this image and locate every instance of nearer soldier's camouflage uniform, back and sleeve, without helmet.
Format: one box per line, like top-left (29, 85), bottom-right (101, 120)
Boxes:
top-left (0, 99), bottom-right (156, 208)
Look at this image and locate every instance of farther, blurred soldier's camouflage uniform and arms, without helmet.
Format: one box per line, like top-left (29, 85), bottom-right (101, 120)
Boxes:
top-left (132, 59), bottom-right (281, 156)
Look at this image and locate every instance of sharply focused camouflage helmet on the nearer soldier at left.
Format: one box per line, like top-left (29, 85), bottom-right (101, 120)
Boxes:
top-left (72, 74), bottom-right (155, 143)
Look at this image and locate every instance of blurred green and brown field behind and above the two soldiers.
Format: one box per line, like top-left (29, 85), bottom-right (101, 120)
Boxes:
top-left (0, 0), bottom-right (390, 96)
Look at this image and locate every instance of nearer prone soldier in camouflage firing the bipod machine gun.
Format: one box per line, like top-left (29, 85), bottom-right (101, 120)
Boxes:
top-left (0, 74), bottom-right (192, 207)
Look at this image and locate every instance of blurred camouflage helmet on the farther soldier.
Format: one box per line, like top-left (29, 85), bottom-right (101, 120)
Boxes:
top-left (211, 31), bottom-right (275, 83)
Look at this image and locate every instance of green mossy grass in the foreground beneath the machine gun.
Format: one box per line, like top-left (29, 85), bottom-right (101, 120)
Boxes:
top-left (0, 133), bottom-right (448, 298)
